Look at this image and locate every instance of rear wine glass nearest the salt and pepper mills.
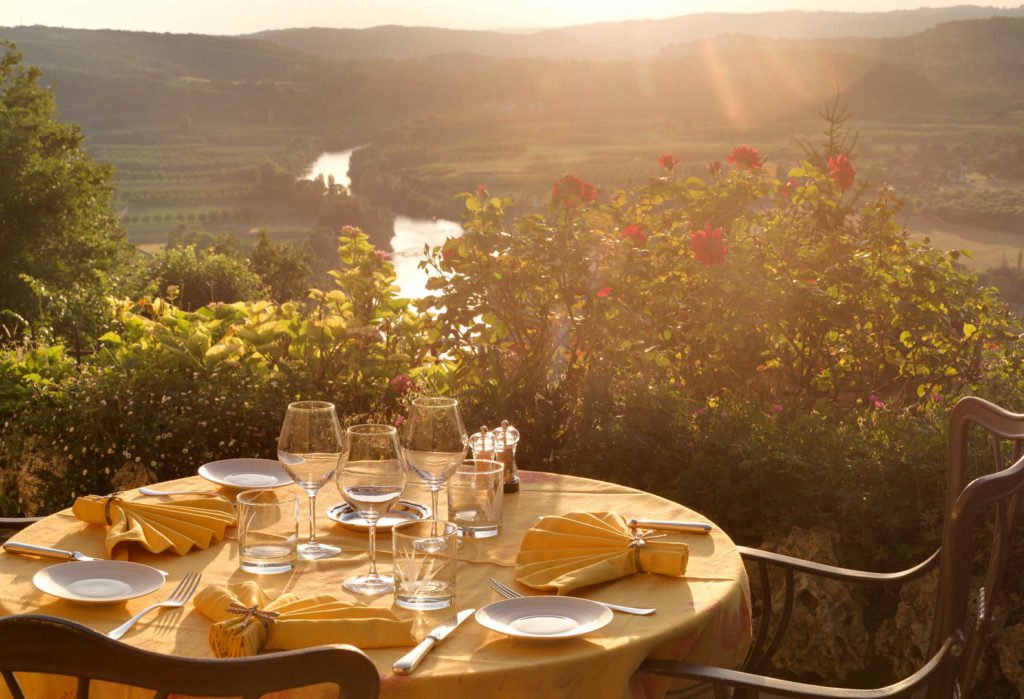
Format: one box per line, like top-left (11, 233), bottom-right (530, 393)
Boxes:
top-left (401, 397), bottom-right (469, 525)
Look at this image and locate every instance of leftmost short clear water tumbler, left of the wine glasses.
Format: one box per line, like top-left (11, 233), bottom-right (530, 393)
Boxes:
top-left (237, 490), bottom-right (299, 575)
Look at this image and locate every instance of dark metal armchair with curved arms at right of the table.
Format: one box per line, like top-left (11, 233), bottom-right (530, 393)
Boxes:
top-left (640, 396), bottom-right (1024, 699)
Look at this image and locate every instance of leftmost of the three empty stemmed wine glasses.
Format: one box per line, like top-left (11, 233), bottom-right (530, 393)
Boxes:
top-left (278, 400), bottom-right (342, 560)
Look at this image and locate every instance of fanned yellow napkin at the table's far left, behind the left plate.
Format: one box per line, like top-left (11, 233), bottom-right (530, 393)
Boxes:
top-left (72, 495), bottom-right (236, 560)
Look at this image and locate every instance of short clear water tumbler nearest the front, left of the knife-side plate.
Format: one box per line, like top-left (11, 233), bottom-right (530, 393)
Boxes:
top-left (391, 520), bottom-right (458, 610)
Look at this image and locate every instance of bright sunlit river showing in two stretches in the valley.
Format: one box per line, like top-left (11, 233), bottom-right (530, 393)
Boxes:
top-left (303, 148), bottom-right (462, 299)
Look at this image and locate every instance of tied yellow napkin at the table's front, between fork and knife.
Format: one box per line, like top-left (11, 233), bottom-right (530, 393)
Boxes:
top-left (193, 581), bottom-right (416, 658)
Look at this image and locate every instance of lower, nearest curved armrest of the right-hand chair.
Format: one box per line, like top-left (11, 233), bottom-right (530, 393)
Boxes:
top-left (637, 637), bottom-right (963, 699)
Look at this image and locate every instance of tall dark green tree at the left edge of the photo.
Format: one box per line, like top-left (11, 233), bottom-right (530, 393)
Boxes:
top-left (0, 42), bottom-right (131, 336)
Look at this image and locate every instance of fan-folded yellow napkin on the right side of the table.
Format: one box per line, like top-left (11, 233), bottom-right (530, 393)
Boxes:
top-left (515, 512), bottom-right (690, 595)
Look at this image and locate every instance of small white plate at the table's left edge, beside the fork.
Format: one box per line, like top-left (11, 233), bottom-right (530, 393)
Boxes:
top-left (32, 561), bottom-right (165, 605)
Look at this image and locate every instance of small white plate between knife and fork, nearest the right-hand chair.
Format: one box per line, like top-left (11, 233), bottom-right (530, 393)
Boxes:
top-left (475, 596), bottom-right (611, 641)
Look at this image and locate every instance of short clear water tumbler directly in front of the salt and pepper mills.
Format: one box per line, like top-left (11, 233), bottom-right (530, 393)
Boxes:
top-left (449, 458), bottom-right (505, 538)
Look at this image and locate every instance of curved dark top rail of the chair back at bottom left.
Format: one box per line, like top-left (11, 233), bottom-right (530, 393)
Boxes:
top-left (0, 614), bottom-right (380, 699)
